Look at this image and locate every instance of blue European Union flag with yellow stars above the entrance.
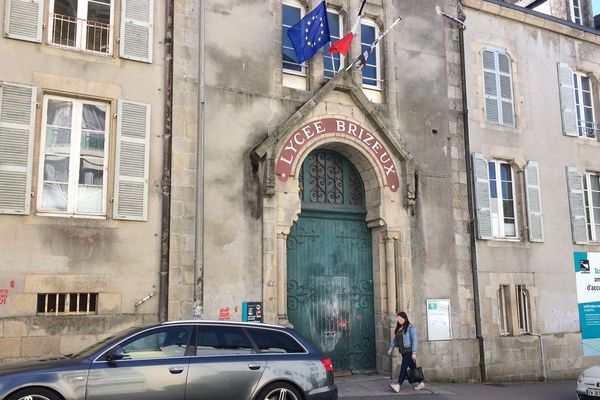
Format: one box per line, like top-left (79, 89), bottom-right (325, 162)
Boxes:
top-left (288, 1), bottom-right (331, 64)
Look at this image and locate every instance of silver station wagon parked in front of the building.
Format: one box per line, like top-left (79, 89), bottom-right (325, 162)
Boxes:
top-left (0, 320), bottom-right (338, 400)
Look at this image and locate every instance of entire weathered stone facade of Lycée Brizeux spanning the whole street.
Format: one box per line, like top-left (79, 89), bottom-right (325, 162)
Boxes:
top-left (0, 0), bottom-right (600, 381)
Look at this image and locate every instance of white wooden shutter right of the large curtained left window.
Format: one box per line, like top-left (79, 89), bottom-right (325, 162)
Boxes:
top-left (113, 100), bottom-right (150, 221)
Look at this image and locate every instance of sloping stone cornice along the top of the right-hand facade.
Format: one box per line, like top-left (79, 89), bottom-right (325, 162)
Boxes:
top-left (462, 0), bottom-right (600, 45)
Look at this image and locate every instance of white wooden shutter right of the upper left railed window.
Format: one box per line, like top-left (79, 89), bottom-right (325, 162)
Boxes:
top-left (121, 0), bottom-right (154, 63)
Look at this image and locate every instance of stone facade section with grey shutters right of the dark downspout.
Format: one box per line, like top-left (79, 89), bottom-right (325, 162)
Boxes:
top-left (463, 0), bottom-right (600, 380)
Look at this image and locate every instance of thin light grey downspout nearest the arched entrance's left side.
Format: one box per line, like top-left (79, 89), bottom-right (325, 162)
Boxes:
top-left (193, 0), bottom-right (206, 319)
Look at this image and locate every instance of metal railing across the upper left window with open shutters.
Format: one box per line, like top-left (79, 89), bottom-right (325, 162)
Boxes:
top-left (50, 13), bottom-right (111, 54)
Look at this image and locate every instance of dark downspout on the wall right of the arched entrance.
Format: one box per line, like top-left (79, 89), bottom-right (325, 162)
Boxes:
top-left (457, 7), bottom-right (487, 382)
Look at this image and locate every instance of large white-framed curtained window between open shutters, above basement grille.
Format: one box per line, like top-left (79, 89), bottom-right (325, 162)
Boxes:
top-left (37, 96), bottom-right (110, 216)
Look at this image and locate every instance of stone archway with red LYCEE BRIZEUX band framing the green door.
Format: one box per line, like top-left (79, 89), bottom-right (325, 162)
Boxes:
top-left (263, 118), bottom-right (412, 371)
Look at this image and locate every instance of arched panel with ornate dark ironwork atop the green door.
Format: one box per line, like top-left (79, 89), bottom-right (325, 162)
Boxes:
top-left (299, 149), bottom-right (365, 211)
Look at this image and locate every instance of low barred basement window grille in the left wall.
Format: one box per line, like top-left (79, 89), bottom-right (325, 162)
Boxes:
top-left (37, 293), bottom-right (98, 315)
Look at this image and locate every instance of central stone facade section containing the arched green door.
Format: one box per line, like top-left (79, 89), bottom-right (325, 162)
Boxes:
top-left (169, 0), bottom-right (480, 380)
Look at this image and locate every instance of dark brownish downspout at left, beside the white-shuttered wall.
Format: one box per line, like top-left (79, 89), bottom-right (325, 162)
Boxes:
top-left (158, 0), bottom-right (174, 322)
